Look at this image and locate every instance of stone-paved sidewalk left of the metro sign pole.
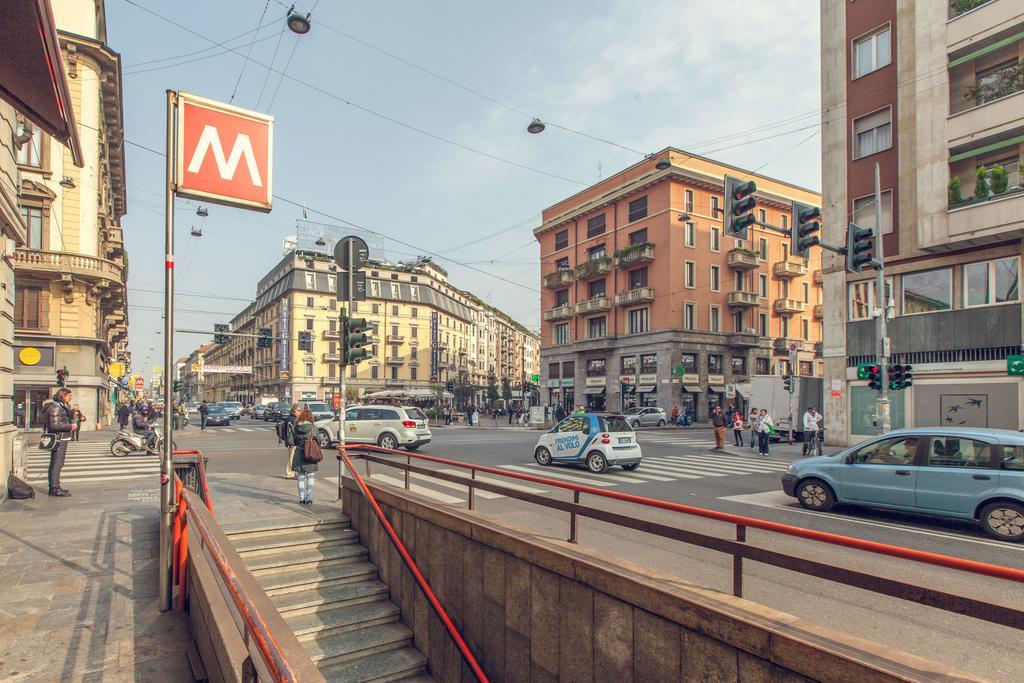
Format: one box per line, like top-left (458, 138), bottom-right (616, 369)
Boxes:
top-left (0, 475), bottom-right (194, 683)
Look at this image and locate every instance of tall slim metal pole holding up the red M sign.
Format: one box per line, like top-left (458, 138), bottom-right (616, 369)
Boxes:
top-left (159, 90), bottom-right (177, 611)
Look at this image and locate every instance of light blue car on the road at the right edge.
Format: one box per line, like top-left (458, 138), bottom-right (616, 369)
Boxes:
top-left (782, 427), bottom-right (1024, 543)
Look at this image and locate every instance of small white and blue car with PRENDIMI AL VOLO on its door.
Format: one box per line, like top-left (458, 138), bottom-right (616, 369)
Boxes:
top-left (534, 413), bottom-right (643, 473)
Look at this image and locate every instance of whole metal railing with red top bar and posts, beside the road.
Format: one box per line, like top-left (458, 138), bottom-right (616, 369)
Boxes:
top-left (344, 444), bottom-right (1024, 630)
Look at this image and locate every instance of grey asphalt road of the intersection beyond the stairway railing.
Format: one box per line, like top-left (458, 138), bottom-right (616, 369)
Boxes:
top-left (176, 418), bottom-right (1024, 681)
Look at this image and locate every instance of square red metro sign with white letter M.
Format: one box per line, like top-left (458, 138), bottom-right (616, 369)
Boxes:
top-left (174, 92), bottom-right (273, 211)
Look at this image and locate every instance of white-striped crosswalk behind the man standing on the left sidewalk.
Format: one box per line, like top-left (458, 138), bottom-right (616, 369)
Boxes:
top-left (26, 441), bottom-right (160, 485)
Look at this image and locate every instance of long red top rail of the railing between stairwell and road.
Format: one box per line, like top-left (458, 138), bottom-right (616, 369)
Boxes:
top-left (340, 444), bottom-right (1024, 584)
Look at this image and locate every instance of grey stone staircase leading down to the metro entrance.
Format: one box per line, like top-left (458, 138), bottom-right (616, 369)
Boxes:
top-left (225, 512), bottom-right (433, 683)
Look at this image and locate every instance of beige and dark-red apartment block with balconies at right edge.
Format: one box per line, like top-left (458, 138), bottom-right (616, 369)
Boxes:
top-left (821, 0), bottom-right (1024, 443)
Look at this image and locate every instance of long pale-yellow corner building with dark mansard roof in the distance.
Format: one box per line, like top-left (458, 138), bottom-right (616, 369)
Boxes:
top-left (193, 251), bottom-right (539, 402)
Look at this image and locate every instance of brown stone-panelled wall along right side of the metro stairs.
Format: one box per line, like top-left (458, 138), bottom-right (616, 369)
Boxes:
top-left (343, 477), bottom-right (974, 683)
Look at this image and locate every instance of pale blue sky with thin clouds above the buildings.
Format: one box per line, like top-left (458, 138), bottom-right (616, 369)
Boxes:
top-left (105, 0), bottom-right (820, 375)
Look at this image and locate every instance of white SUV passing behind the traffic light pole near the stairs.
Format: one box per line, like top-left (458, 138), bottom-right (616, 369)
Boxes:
top-left (315, 405), bottom-right (431, 451)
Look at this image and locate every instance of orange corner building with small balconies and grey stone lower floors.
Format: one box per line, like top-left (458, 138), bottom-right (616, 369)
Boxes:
top-left (534, 147), bottom-right (821, 420)
